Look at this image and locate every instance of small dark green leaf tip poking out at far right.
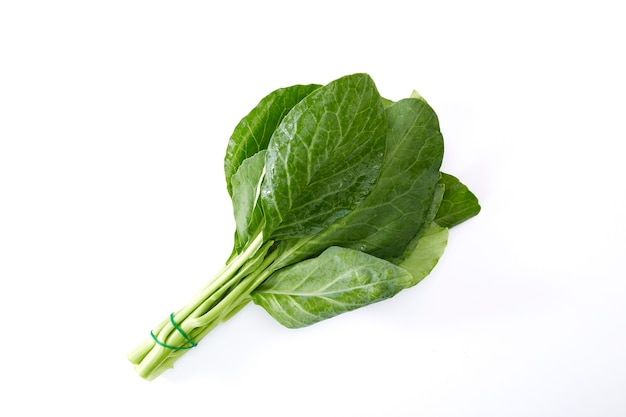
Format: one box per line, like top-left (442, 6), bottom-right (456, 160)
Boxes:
top-left (435, 173), bottom-right (480, 228)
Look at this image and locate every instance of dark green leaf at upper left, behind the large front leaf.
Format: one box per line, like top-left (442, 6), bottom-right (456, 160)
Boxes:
top-left (224, 84), bottom-right (320, 195)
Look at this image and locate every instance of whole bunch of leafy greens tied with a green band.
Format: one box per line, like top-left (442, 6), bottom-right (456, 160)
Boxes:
top-left (129, 74), bottom-right (480, 380)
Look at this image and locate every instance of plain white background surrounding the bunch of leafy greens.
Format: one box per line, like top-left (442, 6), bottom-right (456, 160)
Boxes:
top-left (0, 0), bottom-right (626, 417)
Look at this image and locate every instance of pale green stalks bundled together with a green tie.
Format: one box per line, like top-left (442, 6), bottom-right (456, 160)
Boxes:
top-left (128, 233), bottom-right (276, 380)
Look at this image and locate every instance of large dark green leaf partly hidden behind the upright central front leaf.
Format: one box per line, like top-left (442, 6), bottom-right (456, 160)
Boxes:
top-left (272, 99), bottom-right (443, 261)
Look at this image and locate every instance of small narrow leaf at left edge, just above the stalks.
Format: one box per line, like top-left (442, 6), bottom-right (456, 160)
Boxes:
top-left (231, 150), bottom-right (267, 252)
